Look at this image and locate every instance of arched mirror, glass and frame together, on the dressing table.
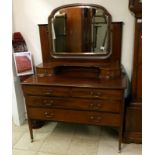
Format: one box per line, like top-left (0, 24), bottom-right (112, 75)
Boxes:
top-left (48, 4), bottom-right (111, 58)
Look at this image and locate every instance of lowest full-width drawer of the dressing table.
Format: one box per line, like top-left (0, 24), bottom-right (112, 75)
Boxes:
top-left (28, 108), bottom-right (120, 126)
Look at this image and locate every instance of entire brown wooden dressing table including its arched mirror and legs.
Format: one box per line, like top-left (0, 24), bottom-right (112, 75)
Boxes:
top-left (22, 4), bottom-right (127, 151)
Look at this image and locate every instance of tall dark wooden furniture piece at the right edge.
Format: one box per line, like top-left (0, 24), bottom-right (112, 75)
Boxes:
top-left (124, 0), bottom-right (142, 143)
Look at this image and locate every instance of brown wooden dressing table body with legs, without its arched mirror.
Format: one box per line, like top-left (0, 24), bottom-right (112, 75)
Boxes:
top-left (21, 4), bottom-right (127, 151)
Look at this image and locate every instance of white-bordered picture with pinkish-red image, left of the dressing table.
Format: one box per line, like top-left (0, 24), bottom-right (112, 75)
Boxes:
top-left (13, 51), bottom-right (34, 76)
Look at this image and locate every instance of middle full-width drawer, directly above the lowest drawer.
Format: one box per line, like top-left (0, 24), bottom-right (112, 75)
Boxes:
top-left (26, 96), bottom-right (121, 113)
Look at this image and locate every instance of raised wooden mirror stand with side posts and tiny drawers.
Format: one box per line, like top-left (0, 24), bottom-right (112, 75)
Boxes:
top-left (36, 4), bottom-right (123, 79)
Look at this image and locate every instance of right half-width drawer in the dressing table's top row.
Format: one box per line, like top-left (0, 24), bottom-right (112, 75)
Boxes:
top-left (72, 88), bottom-right (122, 99)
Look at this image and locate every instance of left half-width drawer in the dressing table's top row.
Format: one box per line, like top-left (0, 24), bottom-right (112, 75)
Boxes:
top-left (23, 85), bottom-right (70, 96)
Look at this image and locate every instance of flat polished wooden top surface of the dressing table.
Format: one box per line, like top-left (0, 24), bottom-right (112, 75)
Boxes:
top-left (22, 74), bottom-right (127, 89)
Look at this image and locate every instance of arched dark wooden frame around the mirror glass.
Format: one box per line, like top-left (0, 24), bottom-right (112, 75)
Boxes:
top-left (48, 3), bottom-right (112, 59)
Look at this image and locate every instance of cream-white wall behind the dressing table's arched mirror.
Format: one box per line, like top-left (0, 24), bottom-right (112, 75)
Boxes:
top-left (13, 0), bottom-right (134, 124)
